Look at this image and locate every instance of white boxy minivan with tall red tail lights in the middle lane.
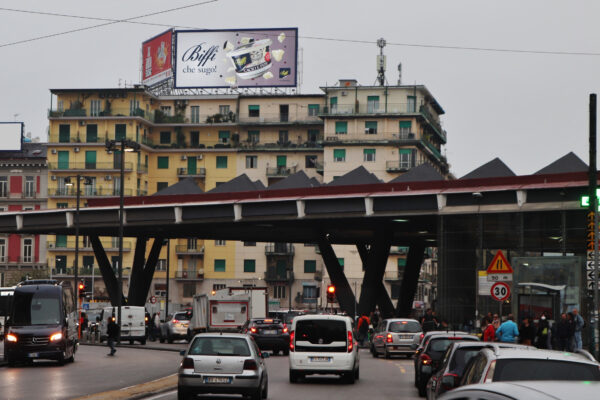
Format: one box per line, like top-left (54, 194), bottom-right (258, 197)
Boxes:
top-left (289, 314), bottom-right (360, 384)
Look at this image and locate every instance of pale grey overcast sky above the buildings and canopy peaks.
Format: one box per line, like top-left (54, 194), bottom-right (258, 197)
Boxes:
top-left (0, 0), bottom-right (600, 177)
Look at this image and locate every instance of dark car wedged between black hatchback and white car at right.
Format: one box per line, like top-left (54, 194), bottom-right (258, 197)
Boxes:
top-left (427, 341), bottom-right (528, 400)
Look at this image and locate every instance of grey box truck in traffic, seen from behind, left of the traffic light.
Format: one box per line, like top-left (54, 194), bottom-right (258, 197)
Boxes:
top-left (188, 287), bottom-right (269, 338)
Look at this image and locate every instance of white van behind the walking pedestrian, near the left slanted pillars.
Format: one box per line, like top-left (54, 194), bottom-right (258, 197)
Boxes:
top-left (100, 306), bottom-right (146, 344)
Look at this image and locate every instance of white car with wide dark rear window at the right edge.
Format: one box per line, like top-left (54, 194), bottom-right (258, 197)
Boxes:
top-left (460, 348), bottom-right (600, 386)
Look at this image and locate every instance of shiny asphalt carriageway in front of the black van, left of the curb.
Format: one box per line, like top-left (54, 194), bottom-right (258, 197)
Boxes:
top-left (0, 344), bottom-right (185, 400)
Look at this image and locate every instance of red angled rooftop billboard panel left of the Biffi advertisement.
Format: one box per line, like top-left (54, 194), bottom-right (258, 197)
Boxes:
top-left (142, 30), bottom-right (173, 85)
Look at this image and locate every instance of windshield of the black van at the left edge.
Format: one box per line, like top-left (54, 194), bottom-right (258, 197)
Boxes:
top-left (13, 291), bottom-right (60, 326)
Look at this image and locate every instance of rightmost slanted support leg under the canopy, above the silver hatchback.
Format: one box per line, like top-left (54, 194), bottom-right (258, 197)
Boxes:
top-left (396, 240), bottom-right (425, 317)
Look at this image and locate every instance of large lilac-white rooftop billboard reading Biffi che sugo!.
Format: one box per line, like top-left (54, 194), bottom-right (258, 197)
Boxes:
top-left (174, 28), bottom-right (298, 88)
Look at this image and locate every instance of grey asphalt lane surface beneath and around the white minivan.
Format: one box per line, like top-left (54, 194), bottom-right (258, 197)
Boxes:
top-left (146, 350), bottom-right (421, 400)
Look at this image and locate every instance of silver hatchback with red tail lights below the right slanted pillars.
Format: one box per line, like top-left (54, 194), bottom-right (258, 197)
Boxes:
top-left (371, 318), bottom-right (422, 358)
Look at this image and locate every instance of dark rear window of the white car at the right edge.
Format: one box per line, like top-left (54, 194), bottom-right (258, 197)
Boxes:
top-left (494, 359), bottom-right (600, 381)
